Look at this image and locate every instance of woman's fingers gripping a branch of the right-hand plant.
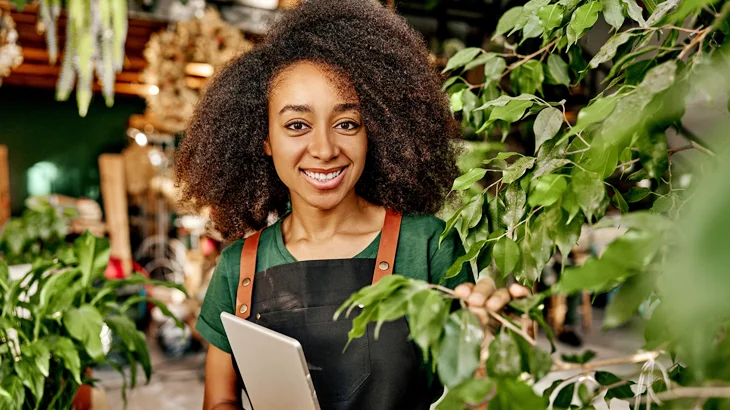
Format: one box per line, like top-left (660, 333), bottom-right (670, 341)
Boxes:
top-left (454, 278), bottom-right (530, 326)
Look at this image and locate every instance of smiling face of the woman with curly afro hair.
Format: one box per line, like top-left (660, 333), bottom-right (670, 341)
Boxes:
top-left (264, 62), bottom-right (368, 210)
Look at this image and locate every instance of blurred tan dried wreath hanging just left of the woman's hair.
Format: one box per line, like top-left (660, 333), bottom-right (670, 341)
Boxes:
top-left (142, 8), bottom-right (253, 132)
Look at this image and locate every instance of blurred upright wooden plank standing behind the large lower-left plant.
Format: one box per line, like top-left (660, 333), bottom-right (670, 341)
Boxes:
top-left (99, 154), bottom-right (132, 276)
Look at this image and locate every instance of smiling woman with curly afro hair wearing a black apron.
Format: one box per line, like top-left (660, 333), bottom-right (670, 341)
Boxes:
top-left (176, 0), bottom-right (526, 410)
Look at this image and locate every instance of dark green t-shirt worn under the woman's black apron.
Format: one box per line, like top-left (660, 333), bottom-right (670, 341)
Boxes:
top-left (195, 215), bottom-right (466, 353)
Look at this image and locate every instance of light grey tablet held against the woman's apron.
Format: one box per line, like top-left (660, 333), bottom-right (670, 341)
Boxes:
top-left (221, 312), bottom-right (319, 410)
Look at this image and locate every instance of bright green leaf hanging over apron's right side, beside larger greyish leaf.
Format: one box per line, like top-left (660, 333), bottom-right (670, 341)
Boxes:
top-left (406, 289), bottom-right (449, 361)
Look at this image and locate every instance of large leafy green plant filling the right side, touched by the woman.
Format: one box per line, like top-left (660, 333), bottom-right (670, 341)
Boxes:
top-left (342, 0), bottom-right (730, 410)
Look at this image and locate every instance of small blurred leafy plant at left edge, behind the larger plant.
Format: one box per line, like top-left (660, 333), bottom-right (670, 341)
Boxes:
top-left (0, 197), bottom-right (76, 265)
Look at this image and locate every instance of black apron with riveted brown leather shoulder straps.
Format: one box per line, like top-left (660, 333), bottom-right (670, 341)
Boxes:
top-left (234, 211), bottom-right (438, 410)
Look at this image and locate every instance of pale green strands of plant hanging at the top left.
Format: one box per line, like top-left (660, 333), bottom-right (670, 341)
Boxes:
top-left (14, 0), bottom-right (127, 117)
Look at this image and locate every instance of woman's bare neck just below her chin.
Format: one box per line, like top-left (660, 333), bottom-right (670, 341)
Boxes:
top-left (282, 192), bottom-right (385, 242)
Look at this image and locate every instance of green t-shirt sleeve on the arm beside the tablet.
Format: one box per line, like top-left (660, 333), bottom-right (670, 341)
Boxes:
top-left (195, 246), bottom-right (240, 353)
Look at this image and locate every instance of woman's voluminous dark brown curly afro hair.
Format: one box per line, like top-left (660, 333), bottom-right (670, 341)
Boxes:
top-left (175, 0), bottom-right (460, 240)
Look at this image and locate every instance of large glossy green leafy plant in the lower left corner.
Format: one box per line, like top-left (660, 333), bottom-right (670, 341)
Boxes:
top-left (0, 232), bottom-right (184, 410)
